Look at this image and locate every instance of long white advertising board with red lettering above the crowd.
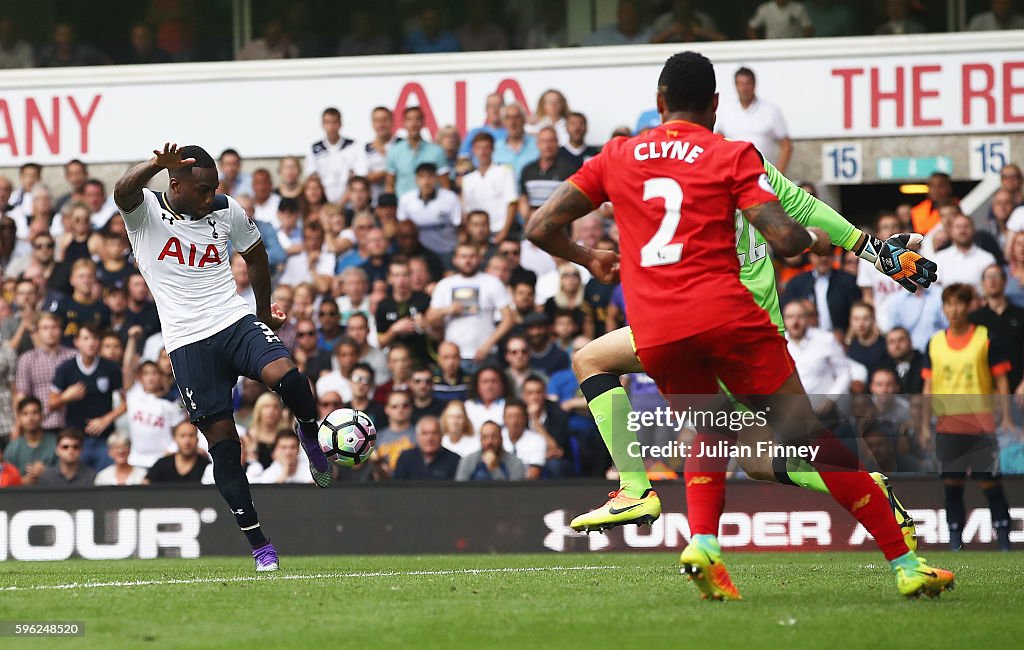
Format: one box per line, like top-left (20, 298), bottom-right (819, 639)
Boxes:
top-left (0, 36), bottom-right (1024, 165)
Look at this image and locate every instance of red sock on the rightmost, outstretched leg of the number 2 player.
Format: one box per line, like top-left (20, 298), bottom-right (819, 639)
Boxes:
top-left (811, 431), bottom-right (909, 560)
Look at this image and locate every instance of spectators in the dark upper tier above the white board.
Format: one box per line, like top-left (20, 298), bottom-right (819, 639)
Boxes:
top-left (0, 0), bottom-right (1024, 69)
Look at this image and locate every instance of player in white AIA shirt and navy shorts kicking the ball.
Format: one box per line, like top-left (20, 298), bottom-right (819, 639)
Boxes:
top-left (114, 143), bottom-right (332, 571)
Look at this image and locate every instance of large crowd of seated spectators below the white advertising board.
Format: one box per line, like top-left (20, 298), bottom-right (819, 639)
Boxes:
top-left (0, 73), bottom-right (1024, 485)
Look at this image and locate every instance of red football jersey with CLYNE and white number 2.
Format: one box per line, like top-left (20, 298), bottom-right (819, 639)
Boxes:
top-left (569, 121), bottom-right (778, 349)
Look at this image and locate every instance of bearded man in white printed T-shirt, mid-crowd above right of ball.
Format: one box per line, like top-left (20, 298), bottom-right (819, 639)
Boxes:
top-left (427, 244), bottom-right (515, 372)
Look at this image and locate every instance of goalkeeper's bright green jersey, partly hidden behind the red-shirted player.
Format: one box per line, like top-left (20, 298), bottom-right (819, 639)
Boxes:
top-left (736, 161), bottom-right (861, 334)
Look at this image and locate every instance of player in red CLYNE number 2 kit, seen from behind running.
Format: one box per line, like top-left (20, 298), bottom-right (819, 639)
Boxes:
top-left (527, 52), bottom-right (953, 598)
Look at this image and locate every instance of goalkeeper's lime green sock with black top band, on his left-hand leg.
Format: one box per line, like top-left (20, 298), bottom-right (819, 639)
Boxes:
top-left (581, 375), bottom-right (650, 499)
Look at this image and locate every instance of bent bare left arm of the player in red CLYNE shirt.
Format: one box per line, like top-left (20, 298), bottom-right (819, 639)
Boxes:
top-left (526, 182), bottom-right (618, 283)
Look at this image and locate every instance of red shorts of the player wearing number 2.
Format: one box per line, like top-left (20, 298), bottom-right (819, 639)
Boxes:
top-left (637, 309), bottom-right (796, 396)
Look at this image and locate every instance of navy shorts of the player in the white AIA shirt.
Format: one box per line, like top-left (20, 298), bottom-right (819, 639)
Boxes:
top-left (170, 314), bottom-right (291, 429)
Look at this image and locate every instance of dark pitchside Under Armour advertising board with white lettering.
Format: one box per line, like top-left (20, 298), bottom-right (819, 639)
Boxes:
top-left (0, 479), bottom-right (1024, 560)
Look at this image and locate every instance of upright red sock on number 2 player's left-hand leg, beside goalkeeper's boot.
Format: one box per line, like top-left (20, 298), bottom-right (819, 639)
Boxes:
top-left (683, 433), bottom-right (731, 535)
